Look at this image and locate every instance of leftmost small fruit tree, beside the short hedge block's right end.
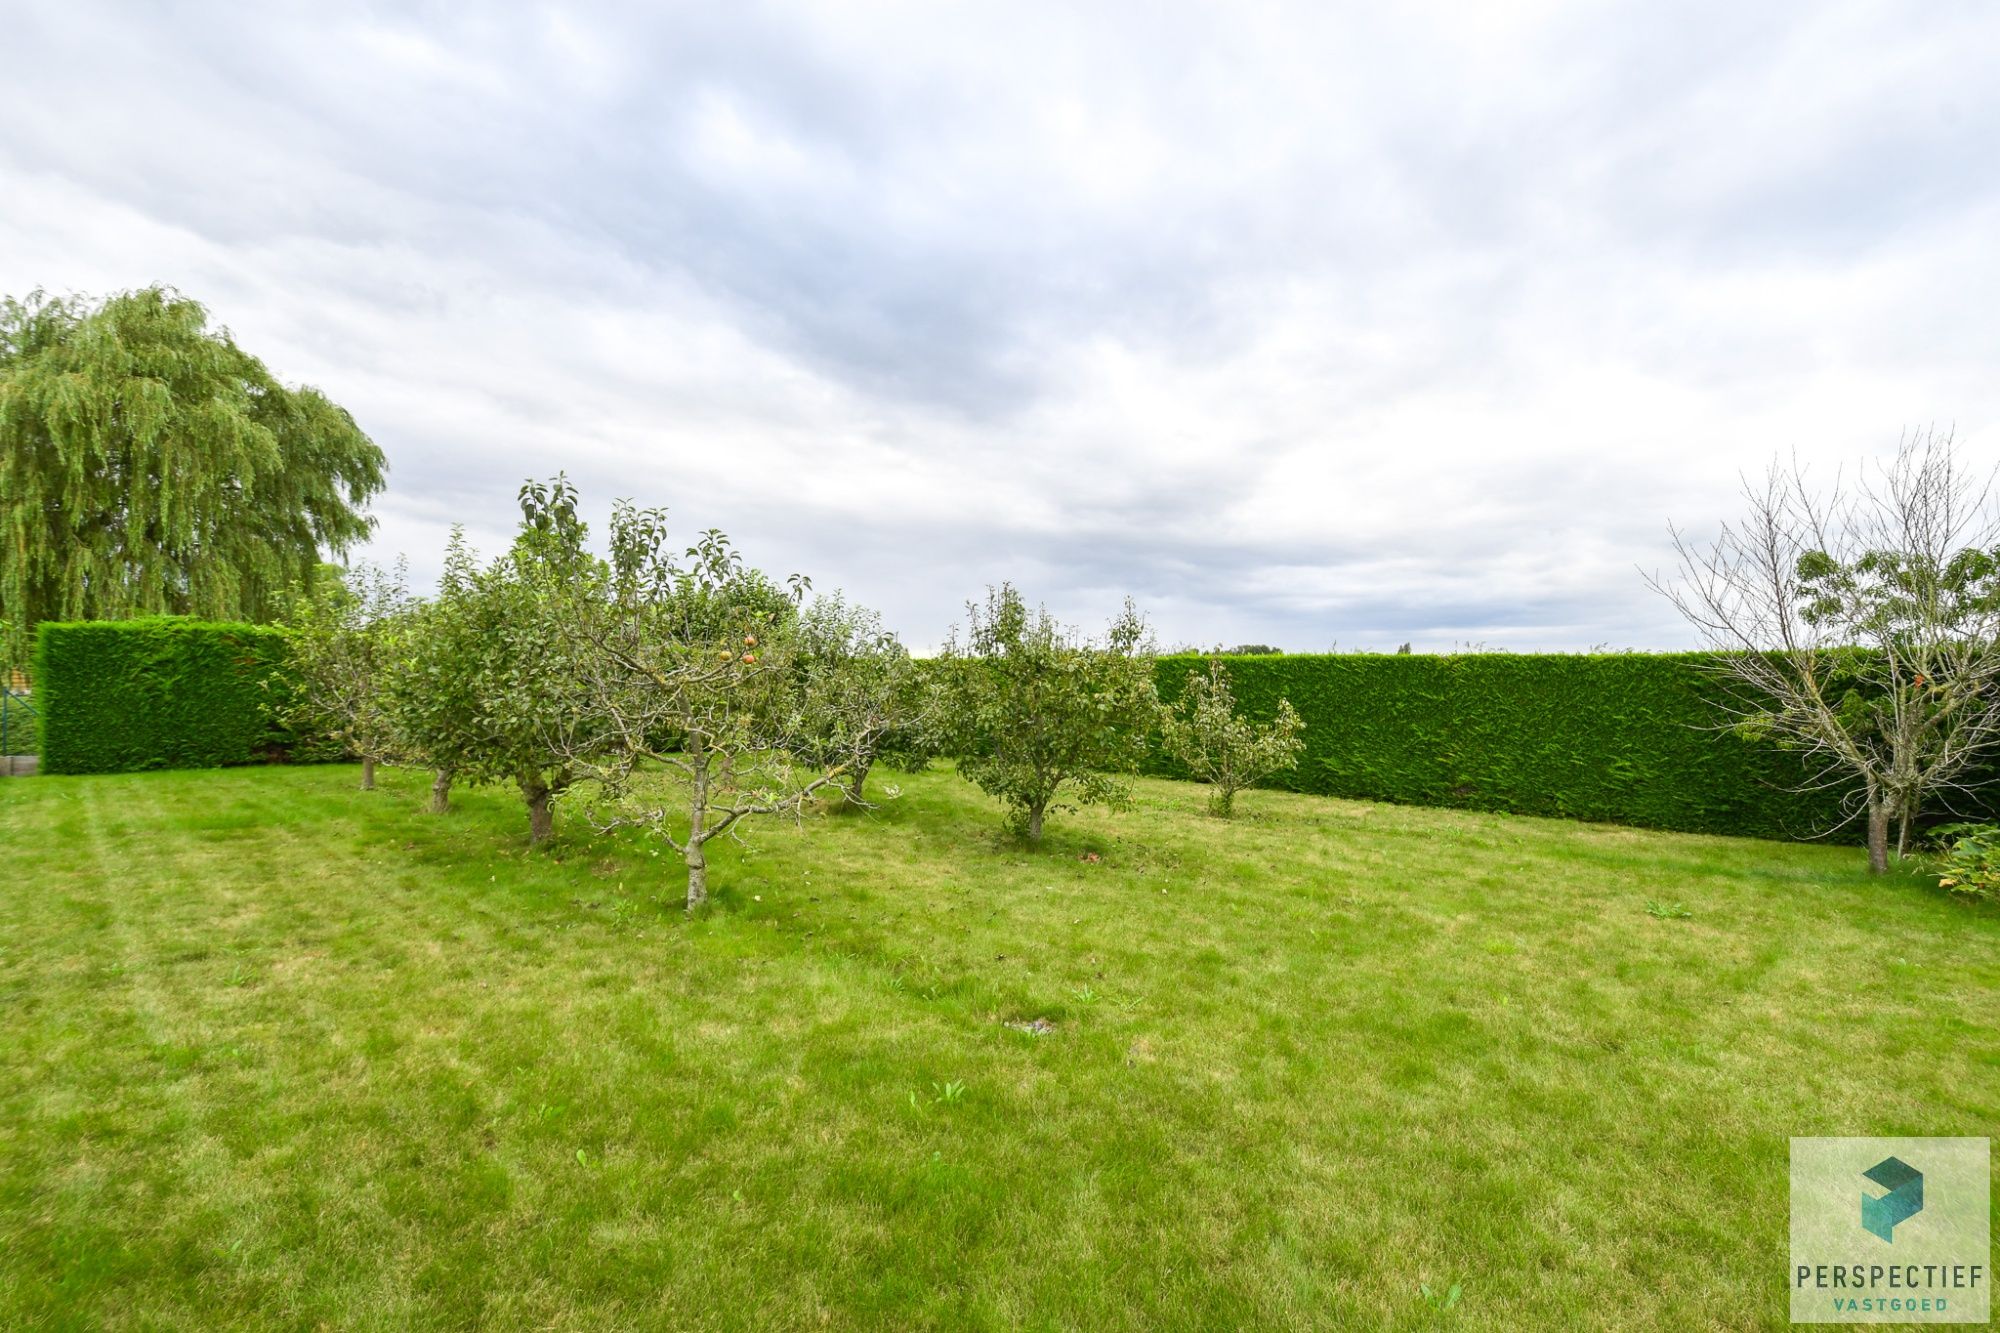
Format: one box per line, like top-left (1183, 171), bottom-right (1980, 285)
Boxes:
top-left (286, 562), bottom-right (414, 791)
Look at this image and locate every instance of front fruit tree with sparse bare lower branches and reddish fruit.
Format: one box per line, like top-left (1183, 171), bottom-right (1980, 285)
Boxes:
top-left (524, 482), bottom-right (850, 911)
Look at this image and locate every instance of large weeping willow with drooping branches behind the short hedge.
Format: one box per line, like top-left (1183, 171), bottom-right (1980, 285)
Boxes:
top-left (0, 286), bottom-right (384, 664)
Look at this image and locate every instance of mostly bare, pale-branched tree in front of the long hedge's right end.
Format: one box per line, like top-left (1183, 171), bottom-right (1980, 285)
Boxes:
top-left (1648, 432), bottom-right (2000, 873)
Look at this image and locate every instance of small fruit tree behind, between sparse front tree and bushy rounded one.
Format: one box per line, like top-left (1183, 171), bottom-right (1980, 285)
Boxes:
top-left (794, 592), bottom-right (928, 807)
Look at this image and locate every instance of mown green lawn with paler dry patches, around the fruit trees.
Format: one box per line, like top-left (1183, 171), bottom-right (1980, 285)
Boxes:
top-left (0, 769), bottom-right (2000, 1329)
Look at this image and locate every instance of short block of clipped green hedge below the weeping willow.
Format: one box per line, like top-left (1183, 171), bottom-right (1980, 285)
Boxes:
top-left (34, 616), bottom-right (300, 773)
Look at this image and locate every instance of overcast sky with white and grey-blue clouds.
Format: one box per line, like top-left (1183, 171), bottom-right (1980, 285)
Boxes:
top-left (0, 0), bottom-right (2000, 650)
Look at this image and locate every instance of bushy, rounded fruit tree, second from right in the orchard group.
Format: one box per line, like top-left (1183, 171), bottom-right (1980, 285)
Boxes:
top-left (940, 582), bottom-right (1160, 841)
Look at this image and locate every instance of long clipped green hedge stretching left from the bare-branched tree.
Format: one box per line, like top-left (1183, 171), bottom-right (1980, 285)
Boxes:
top-left (1158, 652), bottom-right (1880, 839)
